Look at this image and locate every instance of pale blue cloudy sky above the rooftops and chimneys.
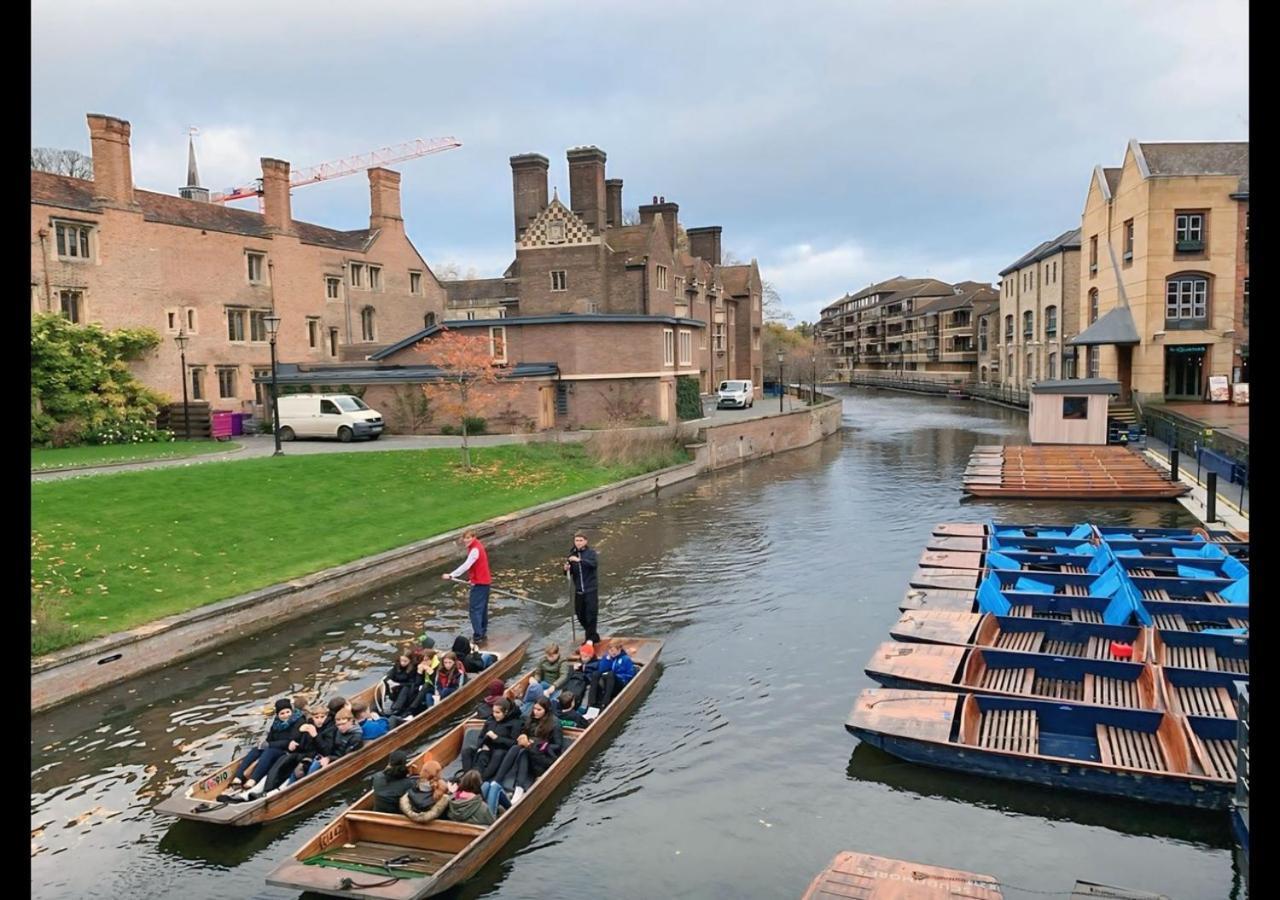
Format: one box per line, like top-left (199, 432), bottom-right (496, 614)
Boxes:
top-left (31, 0), bottom-right (1248, 321)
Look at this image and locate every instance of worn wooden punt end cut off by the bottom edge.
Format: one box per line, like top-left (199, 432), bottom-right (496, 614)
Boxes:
top-left (800, 850), bottom-right (1004, 900)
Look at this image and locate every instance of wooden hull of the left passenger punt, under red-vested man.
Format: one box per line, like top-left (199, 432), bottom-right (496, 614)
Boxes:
top-left (156, 631), bottom-right (532, 826)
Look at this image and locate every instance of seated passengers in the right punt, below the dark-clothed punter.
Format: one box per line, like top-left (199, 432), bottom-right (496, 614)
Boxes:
top-left (374, 641), bottom-right (636, 826)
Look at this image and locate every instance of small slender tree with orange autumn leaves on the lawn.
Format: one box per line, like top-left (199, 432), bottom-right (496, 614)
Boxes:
top-left (415, 328), bottom-right (511, 472)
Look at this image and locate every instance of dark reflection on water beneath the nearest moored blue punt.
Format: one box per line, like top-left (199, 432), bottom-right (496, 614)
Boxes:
top-left (846, 743), bottom-right (1233, 850)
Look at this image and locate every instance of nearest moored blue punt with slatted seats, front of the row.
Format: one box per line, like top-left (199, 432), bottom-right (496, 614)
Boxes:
top-left (845, 689), bottom-right (1236, 809)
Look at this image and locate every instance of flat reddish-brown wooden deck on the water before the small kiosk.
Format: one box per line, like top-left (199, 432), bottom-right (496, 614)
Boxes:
top-left (964, 444), bottom-right (1190, 499)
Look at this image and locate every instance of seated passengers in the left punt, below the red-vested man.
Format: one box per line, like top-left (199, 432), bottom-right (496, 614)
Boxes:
top-left (219, 635), bottom-right (500, 803)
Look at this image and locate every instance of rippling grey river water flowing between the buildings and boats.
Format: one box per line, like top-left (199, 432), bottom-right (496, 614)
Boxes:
top-left (31, 392), bottom-right (1243, 900)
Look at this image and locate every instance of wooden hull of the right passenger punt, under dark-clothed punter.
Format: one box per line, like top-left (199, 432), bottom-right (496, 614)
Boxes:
top-left (259, 638), bottom-right (662, 900)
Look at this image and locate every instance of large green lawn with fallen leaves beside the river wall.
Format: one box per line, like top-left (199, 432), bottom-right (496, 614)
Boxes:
top-left (31, 443), bottom-right (687, 654)
